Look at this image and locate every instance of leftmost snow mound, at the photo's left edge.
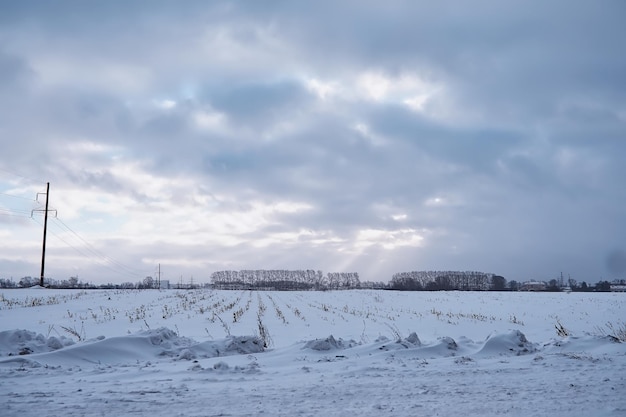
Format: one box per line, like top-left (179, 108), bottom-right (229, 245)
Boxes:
top-left (0, 329), bottom-right (74, 357)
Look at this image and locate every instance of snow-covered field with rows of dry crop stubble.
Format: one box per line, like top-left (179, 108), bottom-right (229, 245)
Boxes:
top-left (0, 289), bottom-right (626, 417)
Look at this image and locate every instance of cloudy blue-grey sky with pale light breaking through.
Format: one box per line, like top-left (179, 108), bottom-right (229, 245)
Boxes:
top-left (0, 0), bottom-right (626, 283)
